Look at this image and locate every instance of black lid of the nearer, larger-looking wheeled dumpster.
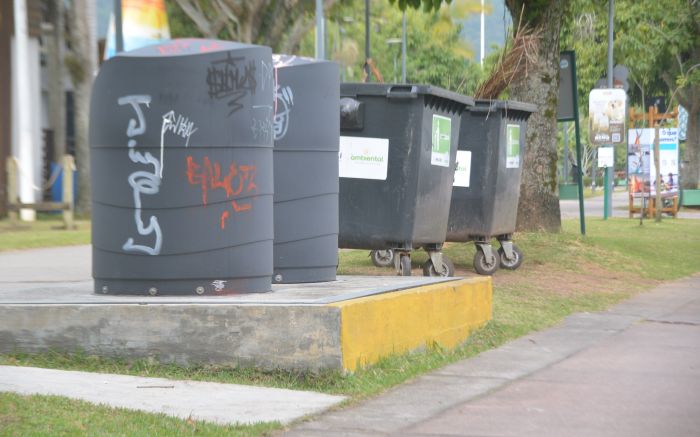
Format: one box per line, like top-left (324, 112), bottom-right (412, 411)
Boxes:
top-left (340, 82), bottom-right (474, 107)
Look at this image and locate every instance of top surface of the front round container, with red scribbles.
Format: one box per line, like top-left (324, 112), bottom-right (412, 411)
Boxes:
top-left (114, 38), bottom-right (263, 58)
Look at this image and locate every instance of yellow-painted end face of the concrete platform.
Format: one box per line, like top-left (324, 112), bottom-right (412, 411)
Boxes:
top-left (329, 277), bottom-right (493, 371)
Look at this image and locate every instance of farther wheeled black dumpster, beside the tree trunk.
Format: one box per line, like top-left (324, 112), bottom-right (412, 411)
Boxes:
top-left (447, 100), bottom-right (537, 275)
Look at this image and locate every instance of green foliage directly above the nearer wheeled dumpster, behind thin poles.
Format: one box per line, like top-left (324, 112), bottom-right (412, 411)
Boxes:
top-left (300, 1), bottom-right (481, 94)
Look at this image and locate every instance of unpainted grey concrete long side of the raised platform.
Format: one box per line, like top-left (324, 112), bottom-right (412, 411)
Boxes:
top-left (0, 304), bottom-right (341, 370)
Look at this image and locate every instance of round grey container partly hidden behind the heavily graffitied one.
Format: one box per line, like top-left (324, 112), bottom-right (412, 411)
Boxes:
top-left (273, 55), bottom-right (340, 283)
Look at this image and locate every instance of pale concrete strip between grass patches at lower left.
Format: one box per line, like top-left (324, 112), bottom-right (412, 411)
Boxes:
top-left (0, 366), bottom-right (345, 424)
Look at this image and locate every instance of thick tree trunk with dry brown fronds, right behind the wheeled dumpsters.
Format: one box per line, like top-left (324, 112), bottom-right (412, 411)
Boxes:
top-left (509, 0), bottom-right (565, 232)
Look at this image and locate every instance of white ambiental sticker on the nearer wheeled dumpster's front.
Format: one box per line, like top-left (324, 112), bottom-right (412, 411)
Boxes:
top-left (338, 137), bottom-right (389, 181)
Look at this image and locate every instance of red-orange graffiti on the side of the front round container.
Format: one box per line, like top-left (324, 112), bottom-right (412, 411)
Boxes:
top-left (187, 156), bottom-right (258, 229)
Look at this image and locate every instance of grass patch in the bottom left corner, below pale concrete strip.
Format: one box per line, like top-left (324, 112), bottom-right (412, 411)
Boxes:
top-left (0, 393), bottom-right (280, 437)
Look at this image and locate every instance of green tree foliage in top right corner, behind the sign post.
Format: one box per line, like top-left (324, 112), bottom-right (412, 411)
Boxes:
top-left (561, 0), bottom-right (700, 105)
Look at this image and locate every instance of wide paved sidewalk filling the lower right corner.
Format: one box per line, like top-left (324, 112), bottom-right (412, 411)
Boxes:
top-left (287, 276), bottom-right (700, 436)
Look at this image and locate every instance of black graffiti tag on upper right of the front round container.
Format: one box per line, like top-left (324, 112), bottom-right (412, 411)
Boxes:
top-left (207, 52), bottom-right (257, 117)
